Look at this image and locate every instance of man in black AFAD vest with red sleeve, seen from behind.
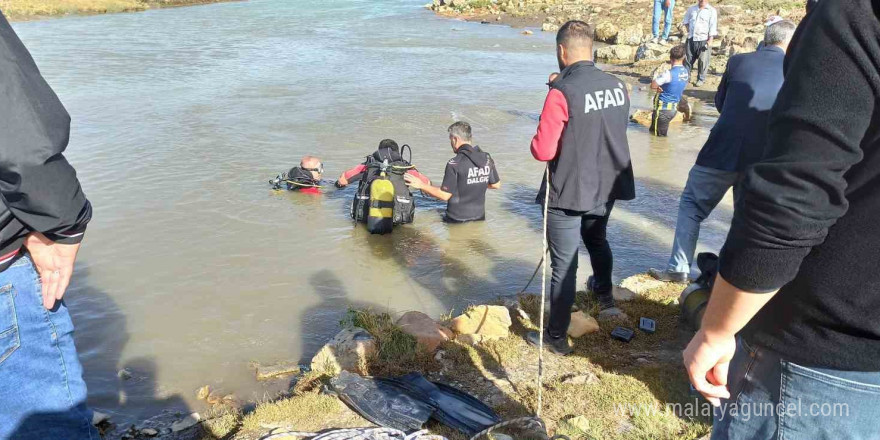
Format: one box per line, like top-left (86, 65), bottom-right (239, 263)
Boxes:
top-left (528, 21), bottom-right (635, 355)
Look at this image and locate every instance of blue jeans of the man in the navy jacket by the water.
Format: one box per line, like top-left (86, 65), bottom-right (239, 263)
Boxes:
top-left (666, 165), bottom-right (740, 273)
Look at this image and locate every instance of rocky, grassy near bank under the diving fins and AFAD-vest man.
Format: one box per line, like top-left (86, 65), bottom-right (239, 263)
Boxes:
top-left (99, 275), bottom-right (709, 440)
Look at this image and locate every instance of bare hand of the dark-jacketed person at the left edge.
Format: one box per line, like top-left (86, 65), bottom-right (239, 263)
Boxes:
top-left (24, 232), bottom-right (79, 310)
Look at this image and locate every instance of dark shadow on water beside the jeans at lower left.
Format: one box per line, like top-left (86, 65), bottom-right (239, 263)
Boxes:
top-left (66, 266), bottom-right (191, 439)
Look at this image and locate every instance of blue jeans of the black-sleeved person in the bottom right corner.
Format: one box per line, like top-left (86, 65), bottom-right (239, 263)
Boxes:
top-left (712, 340), bottom-right (880, 440)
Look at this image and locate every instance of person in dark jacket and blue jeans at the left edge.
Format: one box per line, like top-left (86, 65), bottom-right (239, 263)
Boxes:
top-left (0, 14), bottom-right (99, 439)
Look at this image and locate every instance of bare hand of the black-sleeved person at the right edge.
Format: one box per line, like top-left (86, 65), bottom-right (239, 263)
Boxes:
top-left (683, 330), bottom-right (736, 406)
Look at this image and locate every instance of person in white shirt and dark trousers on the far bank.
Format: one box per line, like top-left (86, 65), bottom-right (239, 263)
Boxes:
top-left (682, 0), bottom-right (718, 87)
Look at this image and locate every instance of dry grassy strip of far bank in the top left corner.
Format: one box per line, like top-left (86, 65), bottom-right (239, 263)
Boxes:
top-left (0, 0), bottom-right (241, 21)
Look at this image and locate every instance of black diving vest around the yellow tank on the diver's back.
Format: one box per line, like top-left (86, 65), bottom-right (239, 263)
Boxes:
top-left (351, 145), bottom-right (416, 226)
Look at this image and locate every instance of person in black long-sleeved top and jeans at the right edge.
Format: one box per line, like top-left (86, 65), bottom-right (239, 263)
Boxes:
top-left (684, 0), bottom-right (880, 439)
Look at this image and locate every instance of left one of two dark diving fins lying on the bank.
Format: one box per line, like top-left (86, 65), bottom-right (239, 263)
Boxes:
top-left (330, 371), bottom-right (434, 432)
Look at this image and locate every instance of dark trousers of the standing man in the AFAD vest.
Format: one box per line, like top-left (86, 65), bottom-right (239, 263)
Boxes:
top-left (547, 202), bottom-right (614, 337)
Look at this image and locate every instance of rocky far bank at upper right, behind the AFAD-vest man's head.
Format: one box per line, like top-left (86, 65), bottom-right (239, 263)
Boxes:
top-left (426, 0), bottom-right (804, 91)
